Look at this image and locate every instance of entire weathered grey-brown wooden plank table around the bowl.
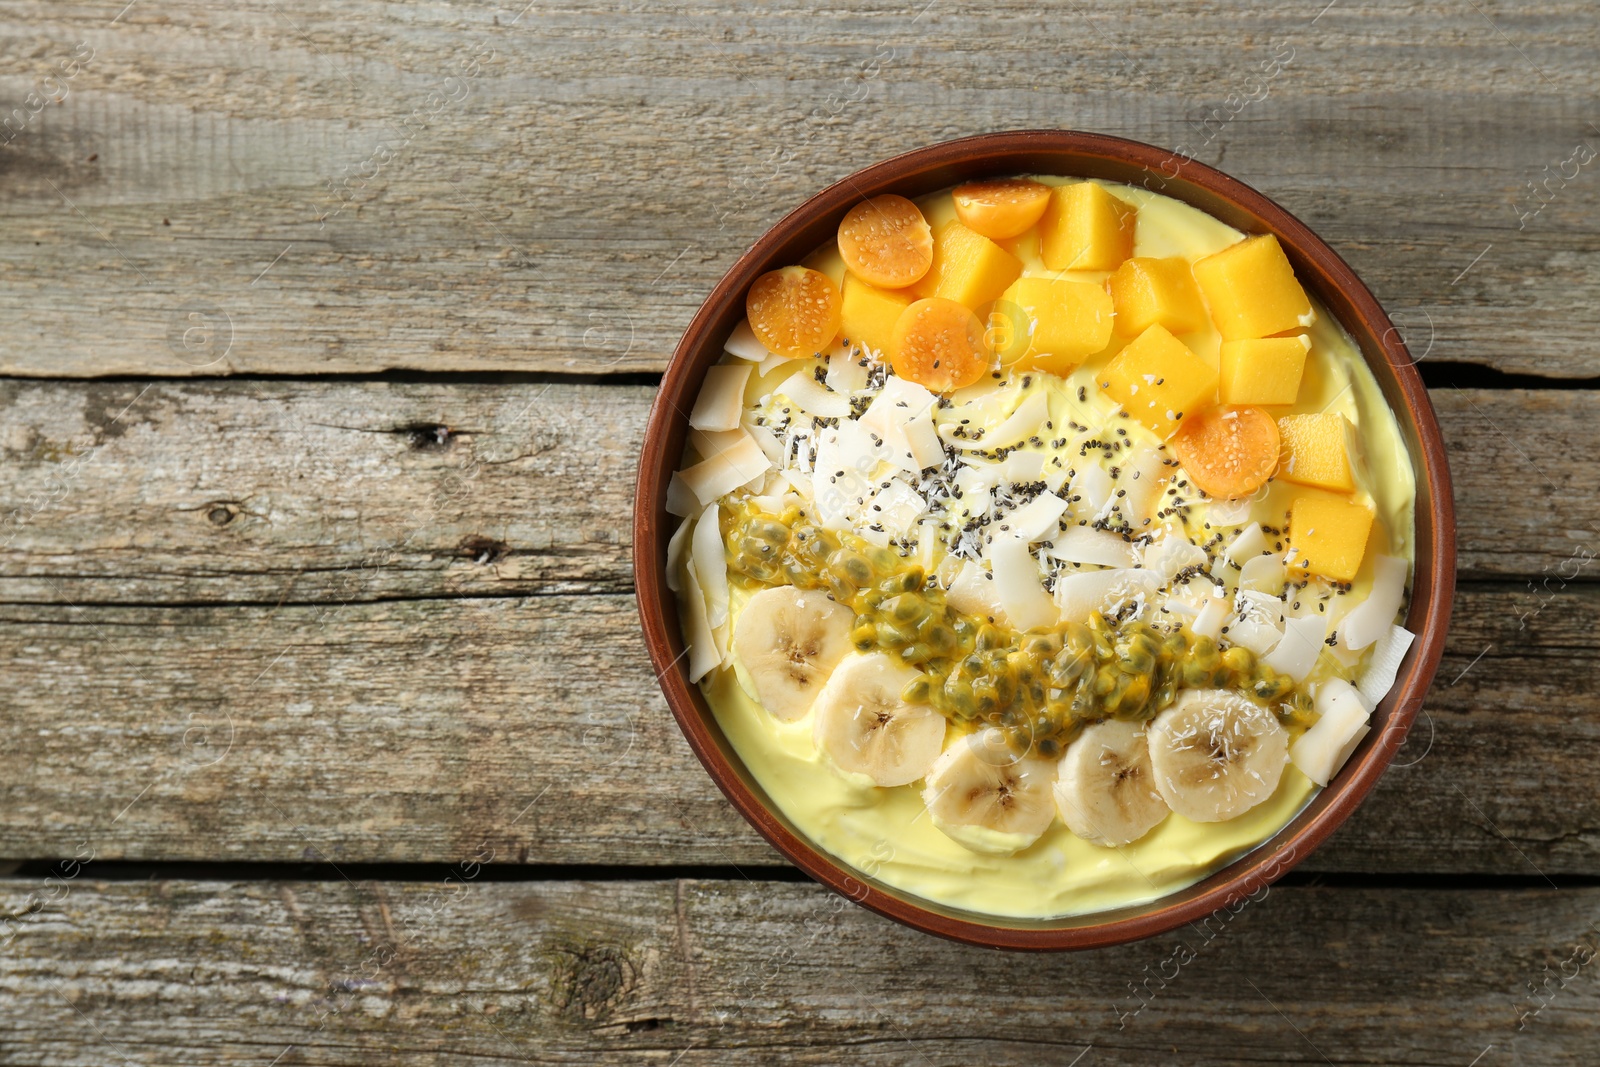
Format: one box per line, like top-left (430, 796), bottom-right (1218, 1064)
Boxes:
top-left (0, 0), bottom-right (1600, 1067)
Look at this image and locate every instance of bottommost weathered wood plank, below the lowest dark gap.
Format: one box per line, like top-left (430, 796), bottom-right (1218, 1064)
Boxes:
top-left (0, 867), bottom-right (1600, 1067)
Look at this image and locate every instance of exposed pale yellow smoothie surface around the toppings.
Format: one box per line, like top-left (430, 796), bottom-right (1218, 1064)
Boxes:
top-left (688, 176), bottom-right (1416, 920)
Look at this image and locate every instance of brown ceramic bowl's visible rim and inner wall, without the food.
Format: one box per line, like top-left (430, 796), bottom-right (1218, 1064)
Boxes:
top-left (634, 130), bottom-right (1456, 950)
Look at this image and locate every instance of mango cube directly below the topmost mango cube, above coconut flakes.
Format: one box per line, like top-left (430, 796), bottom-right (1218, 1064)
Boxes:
top-left (992, 278), bottom-right (1112, 374)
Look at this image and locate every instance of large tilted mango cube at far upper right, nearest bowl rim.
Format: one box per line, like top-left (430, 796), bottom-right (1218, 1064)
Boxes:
top-left (1194, 234), bottom-right (1315, 341)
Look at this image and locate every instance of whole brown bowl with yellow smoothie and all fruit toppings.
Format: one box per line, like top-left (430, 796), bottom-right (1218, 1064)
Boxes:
top-left (634, 131), bottom-right (1454, 949)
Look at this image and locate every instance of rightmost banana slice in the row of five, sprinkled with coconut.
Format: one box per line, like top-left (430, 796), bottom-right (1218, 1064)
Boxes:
top-left (1149, 689), bottom-right (1290, 822)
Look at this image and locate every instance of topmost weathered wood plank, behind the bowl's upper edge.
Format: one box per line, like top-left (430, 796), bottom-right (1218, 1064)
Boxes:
top-left (0, 0), bottom-right (1600, 376)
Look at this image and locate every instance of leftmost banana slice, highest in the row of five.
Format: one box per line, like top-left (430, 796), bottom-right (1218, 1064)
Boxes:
top-left (733, 585), bottom-right (856, 723)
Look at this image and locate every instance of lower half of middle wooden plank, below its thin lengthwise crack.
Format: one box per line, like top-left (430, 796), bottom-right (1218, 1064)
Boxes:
top-left (0, 584), bottom-right (1600, 877)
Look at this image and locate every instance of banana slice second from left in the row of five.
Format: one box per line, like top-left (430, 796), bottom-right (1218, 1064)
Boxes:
top-left (813, 653), bottom-right (944, 785)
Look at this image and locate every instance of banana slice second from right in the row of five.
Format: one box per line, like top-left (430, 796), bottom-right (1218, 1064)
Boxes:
top-left (1056, 720), bottom-right (1168, 848)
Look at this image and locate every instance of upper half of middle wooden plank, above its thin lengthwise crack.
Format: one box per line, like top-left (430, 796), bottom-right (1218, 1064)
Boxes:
top-left (0, 381), bottom-right (1600, 603)
